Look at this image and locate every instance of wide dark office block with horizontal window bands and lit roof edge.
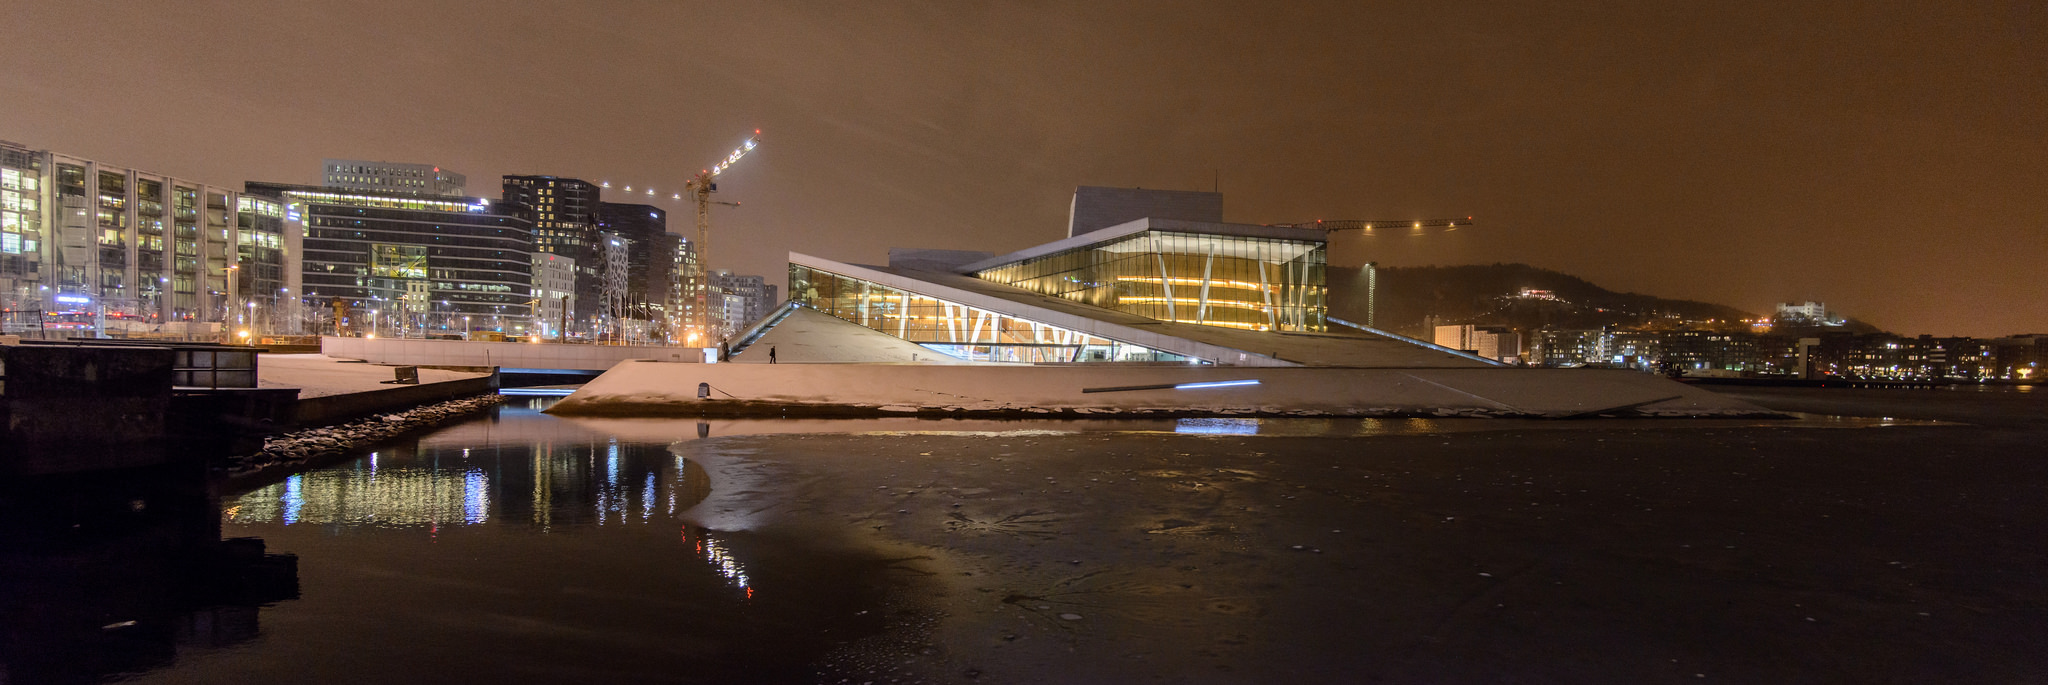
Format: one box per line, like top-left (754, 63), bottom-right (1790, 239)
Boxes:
top-left (248, 180), bottom-right (532, 334)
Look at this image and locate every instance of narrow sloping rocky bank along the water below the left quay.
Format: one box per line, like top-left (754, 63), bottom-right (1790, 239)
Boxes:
top-left (225, 392), bottom-right (506, 480)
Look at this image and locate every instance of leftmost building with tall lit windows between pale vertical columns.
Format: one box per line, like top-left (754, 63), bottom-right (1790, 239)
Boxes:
top-left (0, 142), bottom-right (272, 334)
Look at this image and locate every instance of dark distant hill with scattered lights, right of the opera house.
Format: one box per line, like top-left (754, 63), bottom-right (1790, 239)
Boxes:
top-left (1329, 265), bottom-right (1755, 338)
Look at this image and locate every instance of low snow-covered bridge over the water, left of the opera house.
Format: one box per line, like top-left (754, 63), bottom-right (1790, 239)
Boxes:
top-left (319, 336), bottom-right (717, 373)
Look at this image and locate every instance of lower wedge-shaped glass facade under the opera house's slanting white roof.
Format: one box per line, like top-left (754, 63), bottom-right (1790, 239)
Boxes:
top-left (788, 265), bottom-right (1190, 363)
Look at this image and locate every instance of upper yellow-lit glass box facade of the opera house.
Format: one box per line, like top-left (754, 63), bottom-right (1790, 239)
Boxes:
top-left (975, 230), bottom-right (1329, 330)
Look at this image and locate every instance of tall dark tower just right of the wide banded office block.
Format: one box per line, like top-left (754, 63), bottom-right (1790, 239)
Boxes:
top-left (500, 176), bottom-right (604, 332)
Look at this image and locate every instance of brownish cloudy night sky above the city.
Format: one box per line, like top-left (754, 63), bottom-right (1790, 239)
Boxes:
top-left (0, 0), bottom-right (2048, 336)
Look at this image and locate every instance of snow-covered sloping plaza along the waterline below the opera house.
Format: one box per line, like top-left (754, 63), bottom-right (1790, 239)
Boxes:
top-left (551, 361), bottom-right (1765, 416)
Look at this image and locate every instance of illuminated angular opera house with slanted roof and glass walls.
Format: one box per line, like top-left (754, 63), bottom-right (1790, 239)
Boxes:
top-left (774, 187), bottom-right (1499, 367)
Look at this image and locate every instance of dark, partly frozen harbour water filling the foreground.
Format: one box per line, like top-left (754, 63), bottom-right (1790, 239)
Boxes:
top-left (10, 392), bottom-right (2048, 683)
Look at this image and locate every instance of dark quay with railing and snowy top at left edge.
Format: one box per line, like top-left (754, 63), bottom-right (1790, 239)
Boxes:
top-left (0, 338), bottom-right (498, 478)
